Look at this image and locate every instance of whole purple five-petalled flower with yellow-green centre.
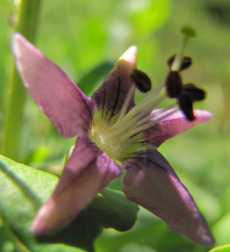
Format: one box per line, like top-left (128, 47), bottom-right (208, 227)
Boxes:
top-left (13, 34), bottom-right (214, 244)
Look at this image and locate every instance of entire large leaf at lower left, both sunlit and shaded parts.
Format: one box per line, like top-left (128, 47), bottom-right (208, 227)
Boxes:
top-left (0, 156), bottom-right (138, 252)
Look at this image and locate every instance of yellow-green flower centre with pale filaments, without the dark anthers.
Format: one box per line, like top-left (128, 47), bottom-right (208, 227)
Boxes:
top-left (90, 83), bottom-right (177, 162)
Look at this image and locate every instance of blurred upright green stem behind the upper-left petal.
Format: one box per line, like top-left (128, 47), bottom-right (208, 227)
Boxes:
top-left (3, 0), bottom-right (41, 159)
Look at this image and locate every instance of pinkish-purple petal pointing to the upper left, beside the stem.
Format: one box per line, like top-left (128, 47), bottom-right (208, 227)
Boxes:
top-left (12, 33), bottom-right (91, 138)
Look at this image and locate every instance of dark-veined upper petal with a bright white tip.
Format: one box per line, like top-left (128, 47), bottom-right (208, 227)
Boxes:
top-left (92, 46), bottom-right (137, 120)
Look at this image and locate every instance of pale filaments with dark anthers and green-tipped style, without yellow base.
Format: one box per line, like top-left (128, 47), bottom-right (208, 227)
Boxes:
top-left (107, 27), bottom-right (201, 142)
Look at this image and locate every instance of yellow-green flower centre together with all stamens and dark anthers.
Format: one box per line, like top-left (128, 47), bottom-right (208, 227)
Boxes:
top-left (90, 28), bottom-right (205, 162)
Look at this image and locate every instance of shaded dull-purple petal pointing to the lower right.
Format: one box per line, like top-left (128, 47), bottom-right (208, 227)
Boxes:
top-left (123, 150), bottom-right (214, 244)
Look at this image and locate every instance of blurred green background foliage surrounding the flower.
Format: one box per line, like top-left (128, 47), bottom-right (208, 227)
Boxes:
top-left (0, 0), bottom-right (230, 252)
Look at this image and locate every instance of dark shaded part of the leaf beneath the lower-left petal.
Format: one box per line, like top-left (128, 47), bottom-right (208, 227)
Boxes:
top-left (40, 188), bottom-right (139, 251)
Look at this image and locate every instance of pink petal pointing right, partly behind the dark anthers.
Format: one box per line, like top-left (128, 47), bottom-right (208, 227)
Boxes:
top-left (144, 110), bottom-right (212, 147)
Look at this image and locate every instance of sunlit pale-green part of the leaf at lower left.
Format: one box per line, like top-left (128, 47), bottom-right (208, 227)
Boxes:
top-left (0, 156), bottom-right (82, 252)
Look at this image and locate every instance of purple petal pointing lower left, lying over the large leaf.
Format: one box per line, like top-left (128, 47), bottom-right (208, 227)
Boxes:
top-left (31, 136), bottom-right (120, 235)
